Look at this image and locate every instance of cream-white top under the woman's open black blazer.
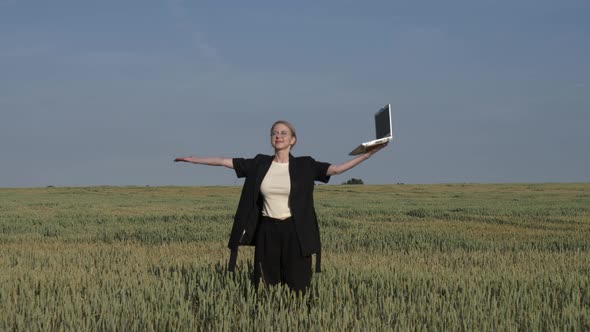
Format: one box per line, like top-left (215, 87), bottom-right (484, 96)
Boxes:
top-left (260, 161), bottom-right (291, 219)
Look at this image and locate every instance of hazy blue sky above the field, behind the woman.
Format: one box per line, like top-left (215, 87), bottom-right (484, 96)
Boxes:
top-left (0, 0), bottom-right (590, 187)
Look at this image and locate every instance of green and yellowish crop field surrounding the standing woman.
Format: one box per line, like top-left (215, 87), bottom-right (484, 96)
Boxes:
top-left (0, 184), bottom-right (590, 331)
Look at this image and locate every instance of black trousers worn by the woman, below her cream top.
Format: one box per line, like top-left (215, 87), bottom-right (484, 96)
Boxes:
top-left (254, 217), bottom-right (312, 292)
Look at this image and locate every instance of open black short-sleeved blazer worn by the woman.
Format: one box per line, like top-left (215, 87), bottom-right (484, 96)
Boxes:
top-left (228, 154), bottom-right (330, 270)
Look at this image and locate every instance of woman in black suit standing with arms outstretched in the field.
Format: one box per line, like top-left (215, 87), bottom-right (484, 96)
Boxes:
top-left (174, 120), bottom-right (387, 292)
